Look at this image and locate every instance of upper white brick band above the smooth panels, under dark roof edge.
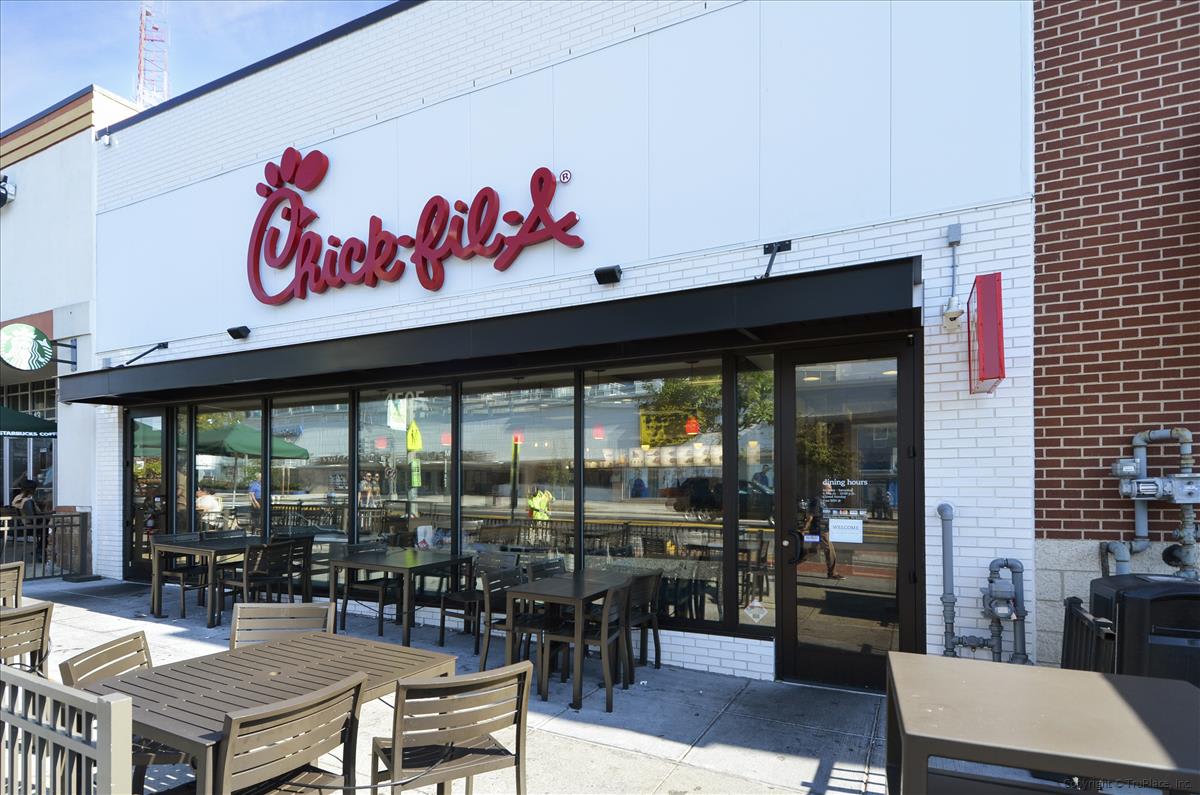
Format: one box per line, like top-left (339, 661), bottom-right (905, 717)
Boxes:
top-left (97, 0), bottom-right (734, 213)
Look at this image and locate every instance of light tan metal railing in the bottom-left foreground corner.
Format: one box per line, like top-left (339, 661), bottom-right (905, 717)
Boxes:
top-left (0, 667), bottom-right (133, 795)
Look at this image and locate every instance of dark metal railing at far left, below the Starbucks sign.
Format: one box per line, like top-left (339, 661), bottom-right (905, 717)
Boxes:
top-left (0, 514), bottom-right (91, 580)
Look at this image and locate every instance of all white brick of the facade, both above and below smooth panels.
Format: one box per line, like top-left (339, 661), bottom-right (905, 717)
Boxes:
top-left (84, 0), bottom-right (1037, 676)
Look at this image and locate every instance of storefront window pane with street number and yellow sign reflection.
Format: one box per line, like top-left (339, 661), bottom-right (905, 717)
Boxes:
top-left (356, 387), bottom-right (451, 548)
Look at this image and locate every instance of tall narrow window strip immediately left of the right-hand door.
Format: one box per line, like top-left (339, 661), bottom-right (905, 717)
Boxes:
top-left (737, 353), bottom-right (776, 628)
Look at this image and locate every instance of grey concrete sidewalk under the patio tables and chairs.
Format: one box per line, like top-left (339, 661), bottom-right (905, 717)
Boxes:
top-left (25, 580), bottom-right (886, 795)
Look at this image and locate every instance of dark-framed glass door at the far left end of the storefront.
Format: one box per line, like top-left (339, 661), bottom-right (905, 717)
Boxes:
top-left (125, 410), bottom-right (170, 580)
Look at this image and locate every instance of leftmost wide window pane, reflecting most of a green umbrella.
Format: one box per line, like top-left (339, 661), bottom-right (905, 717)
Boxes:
top-left (194, 400), bottom-right (263, 533)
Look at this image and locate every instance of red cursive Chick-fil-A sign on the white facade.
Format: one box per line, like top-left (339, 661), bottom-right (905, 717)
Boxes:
top-left (246, 147), bottom-right (583, 305)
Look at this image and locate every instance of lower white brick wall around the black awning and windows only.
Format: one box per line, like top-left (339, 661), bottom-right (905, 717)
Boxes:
top-left (88, 201), bottom-right (1037, 667)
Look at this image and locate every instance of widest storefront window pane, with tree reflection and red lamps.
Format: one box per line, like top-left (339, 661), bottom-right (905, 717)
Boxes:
top-left (583, 360), bottom-right (724, 621)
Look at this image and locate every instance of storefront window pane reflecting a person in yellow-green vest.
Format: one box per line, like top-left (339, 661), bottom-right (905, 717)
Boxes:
top-left (462, 373), bottom-right (575, 568)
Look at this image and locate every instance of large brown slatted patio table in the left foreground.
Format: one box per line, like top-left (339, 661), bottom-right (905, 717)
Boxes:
top-left (85, 633), bottom-right (455, 795)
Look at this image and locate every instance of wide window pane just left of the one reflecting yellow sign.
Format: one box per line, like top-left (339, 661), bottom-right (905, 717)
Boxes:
top-left (270, 393), bottom-right (352, 540)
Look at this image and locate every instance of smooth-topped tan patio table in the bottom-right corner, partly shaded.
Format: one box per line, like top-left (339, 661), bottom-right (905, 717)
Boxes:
top-left (887, 652), bottom-right (1200, 793)
